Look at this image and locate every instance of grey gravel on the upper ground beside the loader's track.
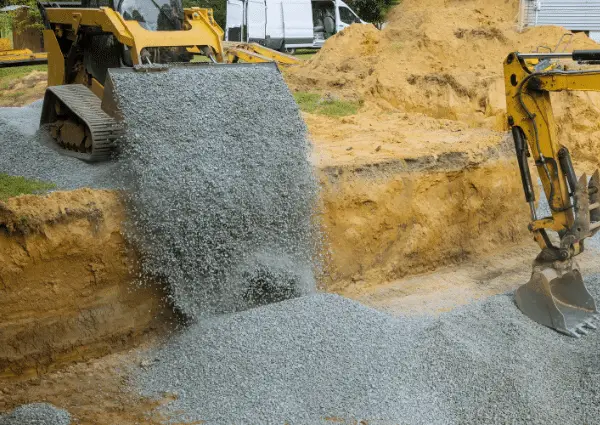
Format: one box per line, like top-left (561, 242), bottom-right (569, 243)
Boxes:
top-left (0, 100), bottom-right (115, 189)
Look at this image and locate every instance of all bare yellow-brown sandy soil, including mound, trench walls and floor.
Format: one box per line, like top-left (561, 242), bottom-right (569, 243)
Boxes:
top-left (0, 0), bottom-right (600, 425)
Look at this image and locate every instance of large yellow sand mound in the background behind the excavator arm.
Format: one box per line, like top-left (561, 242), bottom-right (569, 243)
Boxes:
top-left (288, 0), bottom-right (600, 168)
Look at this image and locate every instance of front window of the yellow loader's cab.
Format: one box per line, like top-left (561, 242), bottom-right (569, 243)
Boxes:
top-left (119, 0), bottom-right (183, 31)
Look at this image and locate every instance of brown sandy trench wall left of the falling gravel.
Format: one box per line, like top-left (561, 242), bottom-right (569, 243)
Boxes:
top-left (0, 189), bottom-right (170, 377)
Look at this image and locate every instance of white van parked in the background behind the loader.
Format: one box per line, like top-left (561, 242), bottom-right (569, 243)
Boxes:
top-left (225, 0), bottom-right (366, 53)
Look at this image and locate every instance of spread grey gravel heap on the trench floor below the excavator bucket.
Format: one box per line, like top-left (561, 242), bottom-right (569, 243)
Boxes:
top-left (137, 275), bottom-right (600, 425)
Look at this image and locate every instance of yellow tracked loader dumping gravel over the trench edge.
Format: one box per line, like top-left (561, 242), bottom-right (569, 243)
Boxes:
top-left (32, 0), bottom-right (294, 162)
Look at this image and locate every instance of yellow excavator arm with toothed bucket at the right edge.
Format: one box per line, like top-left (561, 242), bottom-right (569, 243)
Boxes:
top-left (504, 50), bottom-right (600, 337)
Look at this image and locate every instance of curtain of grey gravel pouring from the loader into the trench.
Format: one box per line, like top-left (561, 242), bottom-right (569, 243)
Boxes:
top-left (111, 66), bottom-right (317, 318)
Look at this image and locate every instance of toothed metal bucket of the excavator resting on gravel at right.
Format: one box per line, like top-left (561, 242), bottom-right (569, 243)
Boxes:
top-left (515, 265), bottom-right (599, 337)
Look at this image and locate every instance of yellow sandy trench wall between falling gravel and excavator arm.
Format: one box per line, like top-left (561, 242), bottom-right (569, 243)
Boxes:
top-left (322, 158), bottom-right (528, 292)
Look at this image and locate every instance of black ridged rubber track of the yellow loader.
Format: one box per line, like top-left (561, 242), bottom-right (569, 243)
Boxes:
top-left (40, 84), bottom-right (123, 162)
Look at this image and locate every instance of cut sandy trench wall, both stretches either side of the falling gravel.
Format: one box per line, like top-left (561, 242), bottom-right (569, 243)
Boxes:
top-left (0, 144), bottom-right (526, 378)
